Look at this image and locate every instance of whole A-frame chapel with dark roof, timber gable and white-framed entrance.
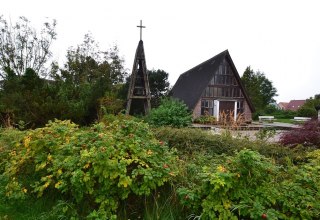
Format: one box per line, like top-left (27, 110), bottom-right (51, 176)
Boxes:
top-left (172, 50), bottom-right (254, 121)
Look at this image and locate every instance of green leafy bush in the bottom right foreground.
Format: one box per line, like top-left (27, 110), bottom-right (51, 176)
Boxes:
top-left (178, 149), bottom-right (320, 219)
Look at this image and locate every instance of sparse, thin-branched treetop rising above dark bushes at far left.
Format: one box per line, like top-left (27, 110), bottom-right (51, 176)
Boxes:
top-left (0, 16), bottom-right (57, 79)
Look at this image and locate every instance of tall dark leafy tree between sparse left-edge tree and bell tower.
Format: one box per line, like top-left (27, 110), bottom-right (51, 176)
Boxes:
top-left (54, 34), bottom-right (126, 124)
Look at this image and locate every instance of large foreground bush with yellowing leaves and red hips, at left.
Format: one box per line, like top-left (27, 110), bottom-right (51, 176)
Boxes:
top-left (0, 118), bottom-right (176, 219)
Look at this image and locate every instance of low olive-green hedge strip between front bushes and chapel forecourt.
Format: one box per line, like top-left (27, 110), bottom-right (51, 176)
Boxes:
top-left (154, 127), bottom-right (315, 163)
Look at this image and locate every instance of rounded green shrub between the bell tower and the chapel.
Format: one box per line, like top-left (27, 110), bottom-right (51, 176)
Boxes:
top-left (146, 99), bottom-right (192, 128)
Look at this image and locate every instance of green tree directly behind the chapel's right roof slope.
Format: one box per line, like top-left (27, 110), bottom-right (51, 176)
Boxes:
top-left (241, 66), bottom-right (277, 111)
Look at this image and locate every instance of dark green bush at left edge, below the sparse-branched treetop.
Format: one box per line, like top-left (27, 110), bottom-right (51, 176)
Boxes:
top-left (0, 68), bottom-right (57, 128)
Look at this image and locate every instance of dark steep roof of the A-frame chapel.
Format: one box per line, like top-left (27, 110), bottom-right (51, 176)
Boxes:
top-left (171, 50), bottom-right (254, 112)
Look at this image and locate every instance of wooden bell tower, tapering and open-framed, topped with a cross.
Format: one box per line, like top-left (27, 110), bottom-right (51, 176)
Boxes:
top-left (126, 21), bottom-right (151, 115)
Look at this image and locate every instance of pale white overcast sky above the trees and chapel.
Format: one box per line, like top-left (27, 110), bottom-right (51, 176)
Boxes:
top-left (0, 0), bottom-right (320, 101)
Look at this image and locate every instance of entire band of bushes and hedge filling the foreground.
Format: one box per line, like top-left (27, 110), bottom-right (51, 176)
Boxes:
top-left (0, 121), bottom-right (320, 219)
